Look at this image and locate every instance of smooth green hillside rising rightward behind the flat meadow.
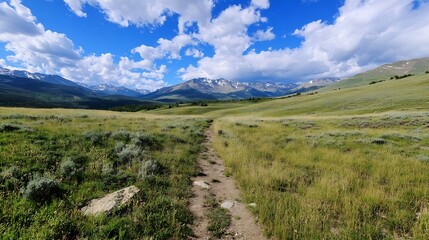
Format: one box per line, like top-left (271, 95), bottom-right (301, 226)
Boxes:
top-left (151, 74), bottom-right (429, 117)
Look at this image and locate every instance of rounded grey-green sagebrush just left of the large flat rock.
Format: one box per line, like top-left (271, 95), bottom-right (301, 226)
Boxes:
top-left (24, 176), bottom-right (61, 203)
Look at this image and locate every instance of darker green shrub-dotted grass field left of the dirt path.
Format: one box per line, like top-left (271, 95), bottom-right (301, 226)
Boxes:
top-left (0, 108), bottom-right (208, 239)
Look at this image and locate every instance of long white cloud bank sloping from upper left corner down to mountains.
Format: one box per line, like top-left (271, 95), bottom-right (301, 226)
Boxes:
top-left (0, 0), bottom-right (167, 90)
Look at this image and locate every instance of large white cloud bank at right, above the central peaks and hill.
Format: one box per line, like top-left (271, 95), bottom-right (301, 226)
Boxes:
top-left (181, 0), bottom-right (429, 81)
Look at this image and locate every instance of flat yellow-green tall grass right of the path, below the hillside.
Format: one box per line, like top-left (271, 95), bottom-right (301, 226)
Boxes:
top-left (215, 113), bottom-right (429, 239)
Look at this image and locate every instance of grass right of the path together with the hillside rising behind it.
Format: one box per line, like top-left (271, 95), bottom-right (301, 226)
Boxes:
top-left (152, 75), bottom-right (429, 239)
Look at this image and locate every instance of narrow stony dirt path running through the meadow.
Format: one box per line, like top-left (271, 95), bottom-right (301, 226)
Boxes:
top-left (190, 126), bottom-right (267, 240)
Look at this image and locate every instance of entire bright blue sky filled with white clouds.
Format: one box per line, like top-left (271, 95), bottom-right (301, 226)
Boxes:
top-left (0, 0), bottom-right (429, 91)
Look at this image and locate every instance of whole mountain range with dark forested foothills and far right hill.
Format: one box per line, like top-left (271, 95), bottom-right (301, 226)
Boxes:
top-left (0, 58), bottom-right (429, 109)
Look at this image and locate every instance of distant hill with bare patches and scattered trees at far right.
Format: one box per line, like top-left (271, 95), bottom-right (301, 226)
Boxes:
top-left (323, 58), bottom-right (429, 91)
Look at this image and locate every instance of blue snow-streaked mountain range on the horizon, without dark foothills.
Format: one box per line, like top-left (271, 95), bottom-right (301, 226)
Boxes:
top-left (0, 68), bottom-right (333, 105)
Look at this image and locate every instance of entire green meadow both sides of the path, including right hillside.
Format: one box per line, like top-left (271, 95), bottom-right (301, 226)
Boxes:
top-left (0, 75), bottom-right (429, 239)
